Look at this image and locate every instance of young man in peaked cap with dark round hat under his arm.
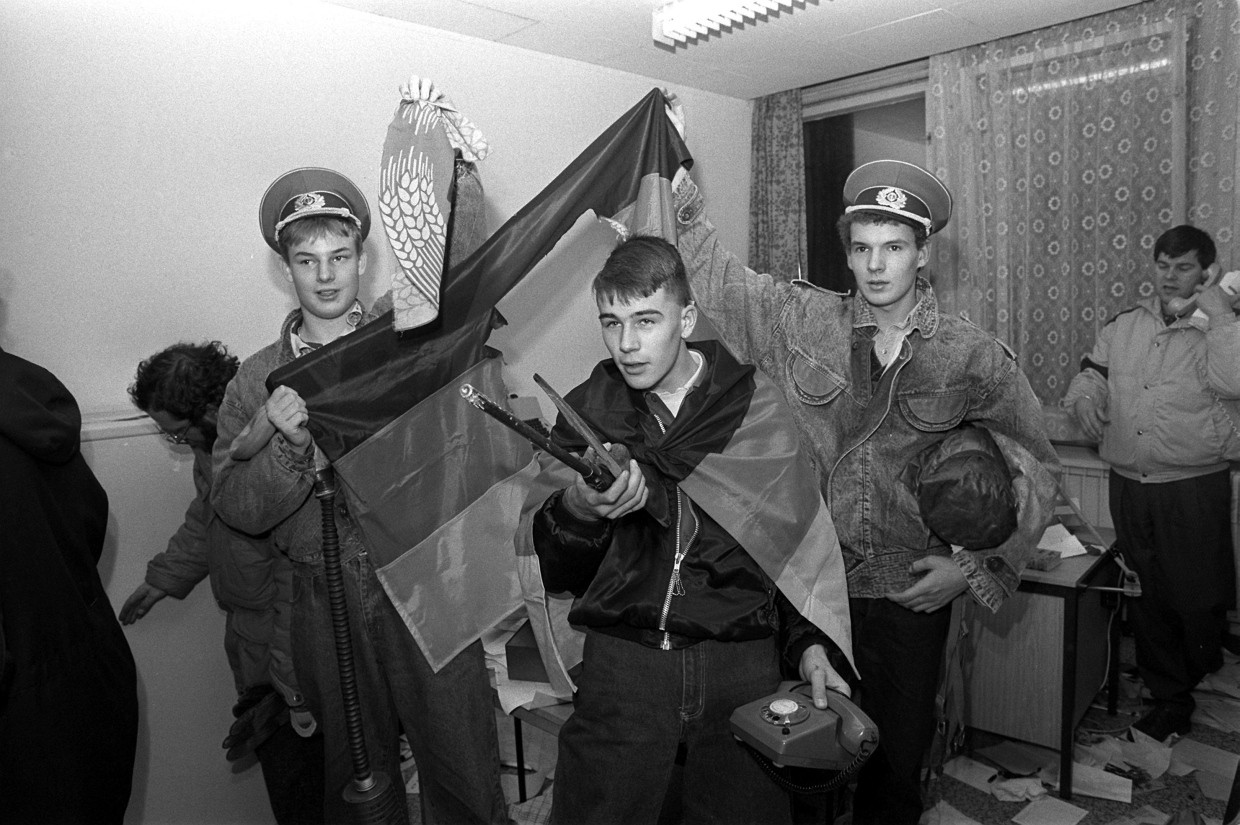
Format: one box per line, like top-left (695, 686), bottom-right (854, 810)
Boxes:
top-left (675, 160), bottom-right (1056, 825)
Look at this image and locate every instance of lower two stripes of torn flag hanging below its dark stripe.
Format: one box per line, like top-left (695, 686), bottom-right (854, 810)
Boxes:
top-left (334, 350), bottom-right (537, 670)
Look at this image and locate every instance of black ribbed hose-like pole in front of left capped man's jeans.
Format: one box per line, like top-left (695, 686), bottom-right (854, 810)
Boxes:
top-left (314, 464), bottom-right (409, 825)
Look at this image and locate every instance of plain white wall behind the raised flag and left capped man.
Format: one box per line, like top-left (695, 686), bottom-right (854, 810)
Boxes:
top-left (0, 0), bottom-right (750, 823)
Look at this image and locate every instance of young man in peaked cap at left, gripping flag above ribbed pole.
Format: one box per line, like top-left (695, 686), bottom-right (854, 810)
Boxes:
top-left (211, 169), bottom-right (507, 823)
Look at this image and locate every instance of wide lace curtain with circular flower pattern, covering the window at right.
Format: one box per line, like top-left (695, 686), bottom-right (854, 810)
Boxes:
top-left (926, 0), bottom-right (1240, 403)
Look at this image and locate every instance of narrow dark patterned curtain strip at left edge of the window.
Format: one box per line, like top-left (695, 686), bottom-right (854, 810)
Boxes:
top-left (749, 89), bottom-right (807, 279)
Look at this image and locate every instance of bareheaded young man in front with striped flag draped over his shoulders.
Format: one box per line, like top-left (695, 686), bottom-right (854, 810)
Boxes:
top-left (526, 236), bottom-right (852, 825)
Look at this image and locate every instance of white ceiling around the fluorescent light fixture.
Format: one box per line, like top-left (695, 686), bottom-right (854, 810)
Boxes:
top-left (322, 0), bottom-right (1133, 99)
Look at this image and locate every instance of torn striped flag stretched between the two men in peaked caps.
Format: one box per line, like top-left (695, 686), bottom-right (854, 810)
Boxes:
top-left (268, 89), bottom-right (692, 669)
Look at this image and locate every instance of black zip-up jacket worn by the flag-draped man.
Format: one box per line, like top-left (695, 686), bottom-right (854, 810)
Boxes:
top-left (533, 341), bottom-right (828, 672)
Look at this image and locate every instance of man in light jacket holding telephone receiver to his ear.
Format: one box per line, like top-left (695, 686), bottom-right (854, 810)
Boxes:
top-left (1061, 226), bottom-right (1240, 741)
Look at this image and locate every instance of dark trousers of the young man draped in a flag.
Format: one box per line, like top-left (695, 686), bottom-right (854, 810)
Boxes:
top-left (551, 630), bottom-right (791, 825)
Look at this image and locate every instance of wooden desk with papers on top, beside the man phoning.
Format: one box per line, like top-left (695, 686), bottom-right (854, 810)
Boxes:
top-left (965, 545), bottom-right (1120, 799)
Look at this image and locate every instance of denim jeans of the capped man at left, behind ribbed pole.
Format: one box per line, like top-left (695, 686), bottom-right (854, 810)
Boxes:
top-left (293, 552), bottom-right (508, 825)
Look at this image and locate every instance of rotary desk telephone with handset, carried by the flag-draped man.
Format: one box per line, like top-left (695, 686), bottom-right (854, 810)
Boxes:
top-left (730, 682), bottom-right (878, 775)
